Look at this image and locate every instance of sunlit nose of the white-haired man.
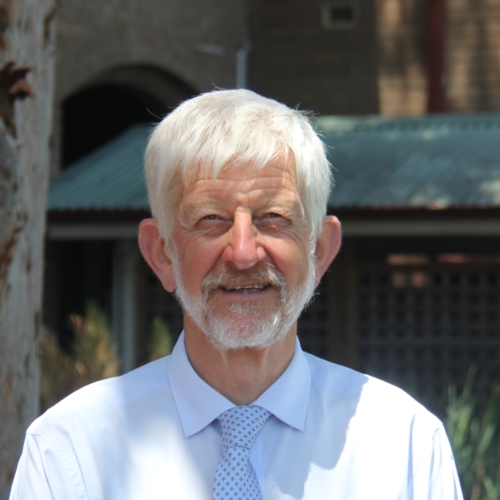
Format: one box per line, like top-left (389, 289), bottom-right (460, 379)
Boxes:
top-left (222, 212), bottom-right (266, 270)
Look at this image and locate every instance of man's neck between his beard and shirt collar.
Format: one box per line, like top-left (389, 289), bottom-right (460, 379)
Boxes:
top-left (184, 314), bottom-right (297, 406)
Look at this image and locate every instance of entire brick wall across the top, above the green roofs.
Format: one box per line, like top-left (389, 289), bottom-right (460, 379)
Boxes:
top-left (56, 0), bottom-right (500, 121)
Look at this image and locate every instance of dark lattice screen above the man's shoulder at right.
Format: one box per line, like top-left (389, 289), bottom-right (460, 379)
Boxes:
top-left (356, 265), bottom-right (500, 396)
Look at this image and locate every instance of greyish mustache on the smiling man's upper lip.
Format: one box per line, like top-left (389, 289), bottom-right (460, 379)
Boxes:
top-left (201, 264), bottom-right (287, 294)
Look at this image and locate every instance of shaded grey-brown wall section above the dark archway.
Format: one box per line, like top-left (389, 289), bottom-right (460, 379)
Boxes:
top-left (56, 0), bottom-right (246, 102)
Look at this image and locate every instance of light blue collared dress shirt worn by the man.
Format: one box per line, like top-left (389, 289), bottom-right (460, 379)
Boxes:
top-left (10, 335), bottom-right (463, 500)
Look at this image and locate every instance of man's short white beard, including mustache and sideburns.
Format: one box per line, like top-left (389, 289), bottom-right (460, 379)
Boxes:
top-left (172, 251), bottom-right (316, 350)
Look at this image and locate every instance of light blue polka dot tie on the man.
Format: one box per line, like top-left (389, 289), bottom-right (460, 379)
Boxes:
top-left (214, 406), bottom-right (270, 500)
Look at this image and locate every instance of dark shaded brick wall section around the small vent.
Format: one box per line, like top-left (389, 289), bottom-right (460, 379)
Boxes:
top-left (249, 0), bottom-right (378, 115)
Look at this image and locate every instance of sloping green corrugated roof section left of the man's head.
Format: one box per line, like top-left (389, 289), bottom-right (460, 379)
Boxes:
top-left (48, 125), bottom-right (151, 211)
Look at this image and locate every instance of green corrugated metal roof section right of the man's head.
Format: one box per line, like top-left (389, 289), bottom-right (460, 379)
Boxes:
top-left (317, 114), bottom-right (500, 208)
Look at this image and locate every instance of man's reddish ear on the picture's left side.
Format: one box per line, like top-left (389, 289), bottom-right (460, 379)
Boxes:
top-left (139, 219), bottom-right (176, 292)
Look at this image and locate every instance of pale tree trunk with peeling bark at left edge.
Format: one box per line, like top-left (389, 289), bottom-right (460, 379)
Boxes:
top-left (0, 0), bottom-right (56, 492)
